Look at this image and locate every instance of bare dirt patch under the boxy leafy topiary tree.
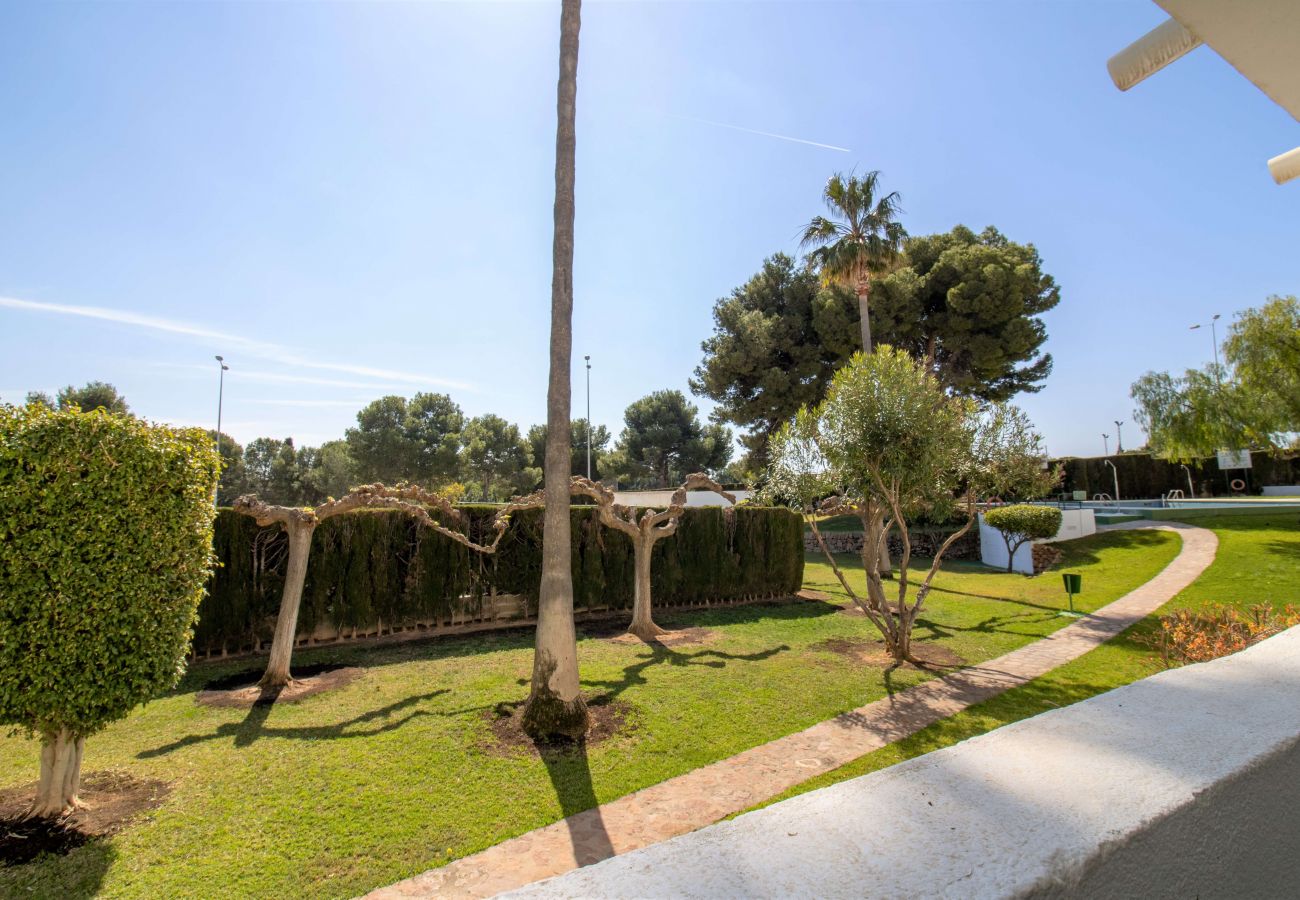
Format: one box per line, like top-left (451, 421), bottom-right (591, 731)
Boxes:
top-left (0, 771), bottom-right (170, 867)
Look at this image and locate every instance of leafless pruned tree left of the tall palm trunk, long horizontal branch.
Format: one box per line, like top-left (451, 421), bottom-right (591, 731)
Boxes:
top-left (234, 484), bottom-right (530, 691)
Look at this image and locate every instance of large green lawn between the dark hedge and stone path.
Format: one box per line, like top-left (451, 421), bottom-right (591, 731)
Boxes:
top-left (0, 522), bottom-right (1179, 897)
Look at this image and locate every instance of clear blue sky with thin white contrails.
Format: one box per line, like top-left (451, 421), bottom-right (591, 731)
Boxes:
top-left (0, 0), bottom-right (1300, 454)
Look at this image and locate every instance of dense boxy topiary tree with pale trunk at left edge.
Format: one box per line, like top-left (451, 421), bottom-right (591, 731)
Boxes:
top-left (0, 404), bottom-right (218, 815)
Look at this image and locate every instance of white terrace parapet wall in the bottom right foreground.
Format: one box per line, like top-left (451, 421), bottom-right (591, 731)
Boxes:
top-left (508, 627), bottom-right (1300, 900)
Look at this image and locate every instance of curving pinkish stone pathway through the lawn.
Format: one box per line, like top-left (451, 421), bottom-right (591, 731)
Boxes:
top-left (368, 522), bottom-right (1218, 900)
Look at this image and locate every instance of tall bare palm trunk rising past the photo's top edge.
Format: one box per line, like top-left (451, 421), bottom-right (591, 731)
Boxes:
top-left (523, 0), bottom-right (589, 739)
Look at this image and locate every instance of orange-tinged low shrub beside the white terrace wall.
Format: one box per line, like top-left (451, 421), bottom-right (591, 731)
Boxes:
top-left (1145, 605), bottom-right (1300, 668)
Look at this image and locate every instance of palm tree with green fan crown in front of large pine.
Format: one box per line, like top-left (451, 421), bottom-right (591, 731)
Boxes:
top-left (801, 172), bottom-right (907, 352)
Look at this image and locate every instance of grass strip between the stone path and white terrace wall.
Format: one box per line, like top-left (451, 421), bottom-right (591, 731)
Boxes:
top-left (763, 514), bottom-right (1300, 805)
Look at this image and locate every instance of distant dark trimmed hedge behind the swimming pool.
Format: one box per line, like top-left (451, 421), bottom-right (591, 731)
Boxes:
top-left (1057, 451), bottom-right (1300, 499)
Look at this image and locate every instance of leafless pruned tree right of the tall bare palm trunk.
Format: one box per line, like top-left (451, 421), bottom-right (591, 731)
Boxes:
top-left (572, 472), bottom-right (736, 641)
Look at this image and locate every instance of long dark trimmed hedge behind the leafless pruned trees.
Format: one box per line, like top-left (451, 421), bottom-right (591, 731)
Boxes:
top-left (194, 505), bottom-right (803, 654)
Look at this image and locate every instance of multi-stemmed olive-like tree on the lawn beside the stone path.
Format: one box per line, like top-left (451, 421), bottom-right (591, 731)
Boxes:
top-left (764, 345), bottom-right (1052, 663)
